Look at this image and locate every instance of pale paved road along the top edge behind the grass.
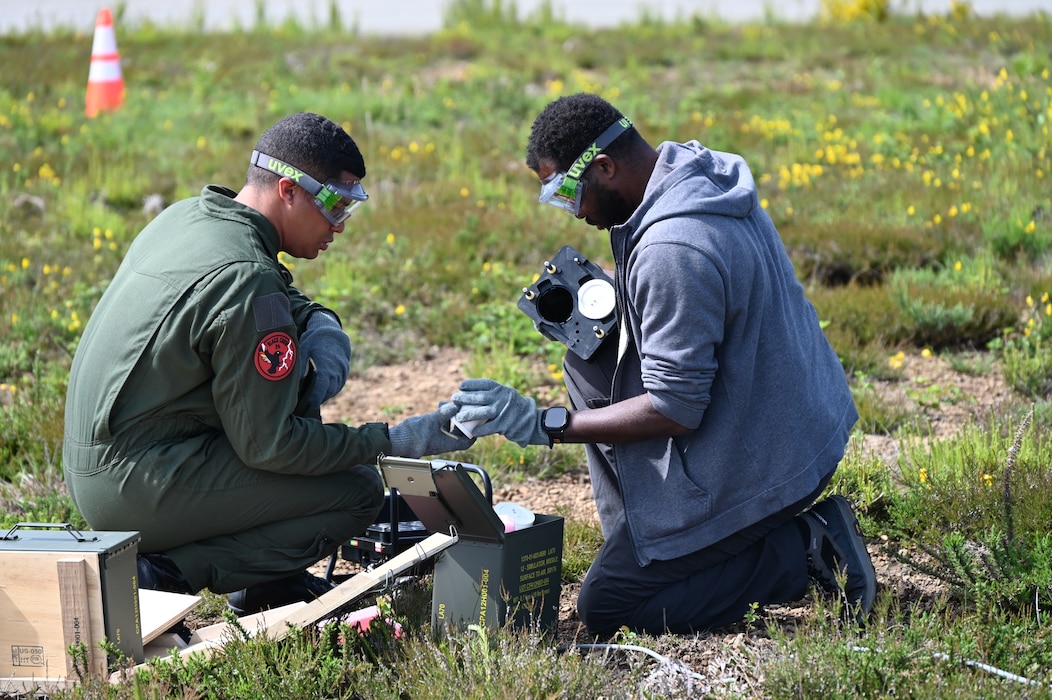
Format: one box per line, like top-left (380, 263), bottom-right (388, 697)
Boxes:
top-left (0, 0), bottom-right (1052, 35)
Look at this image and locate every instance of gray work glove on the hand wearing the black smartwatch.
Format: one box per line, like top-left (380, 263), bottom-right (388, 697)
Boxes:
top-left (452, 379), bottom-right (551, 447)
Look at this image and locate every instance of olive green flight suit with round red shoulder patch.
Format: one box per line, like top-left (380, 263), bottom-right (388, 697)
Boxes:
top-left (63, 185), bottom-right (390, 593)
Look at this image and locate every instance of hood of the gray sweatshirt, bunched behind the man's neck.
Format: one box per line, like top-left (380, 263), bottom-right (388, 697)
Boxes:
top-left (611, 141), bottom-right (760, 245)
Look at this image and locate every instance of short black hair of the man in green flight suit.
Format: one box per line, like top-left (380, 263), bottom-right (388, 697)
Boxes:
top-left (247, 112), bottom-right (365, 183)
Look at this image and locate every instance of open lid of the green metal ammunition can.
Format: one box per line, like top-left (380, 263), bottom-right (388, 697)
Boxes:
top-left (380, 457), bottom-right (504, 542)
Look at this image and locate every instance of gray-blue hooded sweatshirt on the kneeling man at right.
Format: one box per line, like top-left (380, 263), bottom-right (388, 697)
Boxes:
top-left (591, 141), bottom-right (858, 565)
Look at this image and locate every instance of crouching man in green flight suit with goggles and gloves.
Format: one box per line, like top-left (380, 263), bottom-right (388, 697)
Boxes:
top-left (63, 113), bottom-right (472, 614)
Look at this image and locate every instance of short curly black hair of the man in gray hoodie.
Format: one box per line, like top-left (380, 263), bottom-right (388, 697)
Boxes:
top-left (526, 93), bottom-right (635, 172)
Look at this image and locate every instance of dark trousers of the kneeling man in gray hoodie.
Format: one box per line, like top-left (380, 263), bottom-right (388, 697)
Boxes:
top-left (564, 338), bottom-right (828, 635)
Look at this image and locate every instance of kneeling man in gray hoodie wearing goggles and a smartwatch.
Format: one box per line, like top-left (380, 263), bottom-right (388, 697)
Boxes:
top-left (453, 94), bottom-right (876, 634)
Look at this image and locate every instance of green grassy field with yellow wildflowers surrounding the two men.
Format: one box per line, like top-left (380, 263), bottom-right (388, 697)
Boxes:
top-left (6, 0), bottom-right (1052, 698)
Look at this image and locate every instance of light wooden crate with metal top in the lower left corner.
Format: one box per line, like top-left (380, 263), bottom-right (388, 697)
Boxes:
top-left (0, 523), bottom-right (143, 693)
